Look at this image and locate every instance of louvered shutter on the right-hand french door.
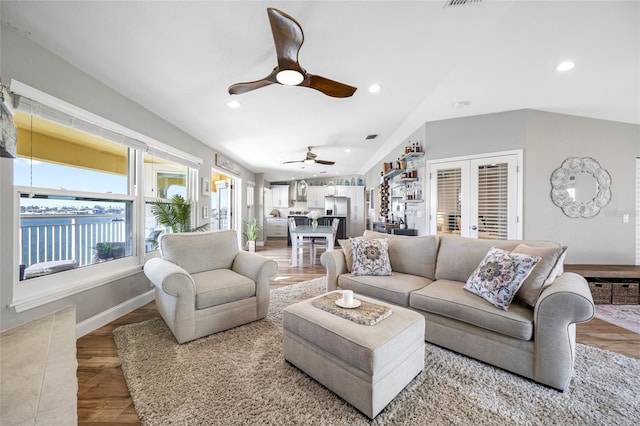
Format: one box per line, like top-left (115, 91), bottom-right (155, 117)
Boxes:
top-left (478, 163), bottom-right (509, 240)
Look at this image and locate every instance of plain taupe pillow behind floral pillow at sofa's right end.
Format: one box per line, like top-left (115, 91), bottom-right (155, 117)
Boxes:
top-left (513, 244), bottom-right (567, 306)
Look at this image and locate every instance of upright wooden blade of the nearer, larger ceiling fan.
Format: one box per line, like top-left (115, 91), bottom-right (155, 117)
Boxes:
top-left (267, 7), bottom-right (304, 70)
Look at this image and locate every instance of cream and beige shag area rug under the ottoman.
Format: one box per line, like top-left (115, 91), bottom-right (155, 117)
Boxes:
top-left (114, 279), bottom-right (640, 425)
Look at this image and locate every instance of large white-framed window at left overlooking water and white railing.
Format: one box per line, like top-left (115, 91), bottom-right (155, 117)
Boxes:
top-left (10, 80), bottom-right (202, 312)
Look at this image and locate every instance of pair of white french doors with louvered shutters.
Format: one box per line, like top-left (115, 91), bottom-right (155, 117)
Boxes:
top-left (427, 151), bottom-right (522, 239)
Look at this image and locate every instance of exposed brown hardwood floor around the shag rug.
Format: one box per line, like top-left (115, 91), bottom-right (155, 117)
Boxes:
top-left (76, 239), bottom-right (640, 425)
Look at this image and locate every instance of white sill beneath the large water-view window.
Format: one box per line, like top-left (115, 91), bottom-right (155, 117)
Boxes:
top-left (9, 265), bottom-right (142, 313)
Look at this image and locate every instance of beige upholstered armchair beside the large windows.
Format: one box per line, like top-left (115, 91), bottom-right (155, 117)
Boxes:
top-left (144, 230), bottom-right (278, 343)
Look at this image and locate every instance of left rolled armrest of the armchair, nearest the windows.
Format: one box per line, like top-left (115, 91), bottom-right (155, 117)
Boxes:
top-left (144, 257), bottom-right (196, 298)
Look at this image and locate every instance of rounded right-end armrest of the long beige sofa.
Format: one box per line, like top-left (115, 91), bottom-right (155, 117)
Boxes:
top-left (533, 272), bottom-right (595, 390)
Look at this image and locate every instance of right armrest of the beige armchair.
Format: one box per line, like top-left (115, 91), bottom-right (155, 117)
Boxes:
top-left (231, 251), bottom-right (278, 318)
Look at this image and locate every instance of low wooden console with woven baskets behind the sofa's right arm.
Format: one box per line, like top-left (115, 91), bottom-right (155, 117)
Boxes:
top-left (564, 264), bottom-right (640, 305)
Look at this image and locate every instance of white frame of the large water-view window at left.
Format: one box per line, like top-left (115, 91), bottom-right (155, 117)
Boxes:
top-left (9, 80), bottom-right (203, 313)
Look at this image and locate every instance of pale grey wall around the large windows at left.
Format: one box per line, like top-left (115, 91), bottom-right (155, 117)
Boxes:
top-left (0, 25), bottom-right (255, 330)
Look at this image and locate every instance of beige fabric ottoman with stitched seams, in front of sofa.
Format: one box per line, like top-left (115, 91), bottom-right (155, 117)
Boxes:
top-left (282, 295), bottom-right (425, 419)
